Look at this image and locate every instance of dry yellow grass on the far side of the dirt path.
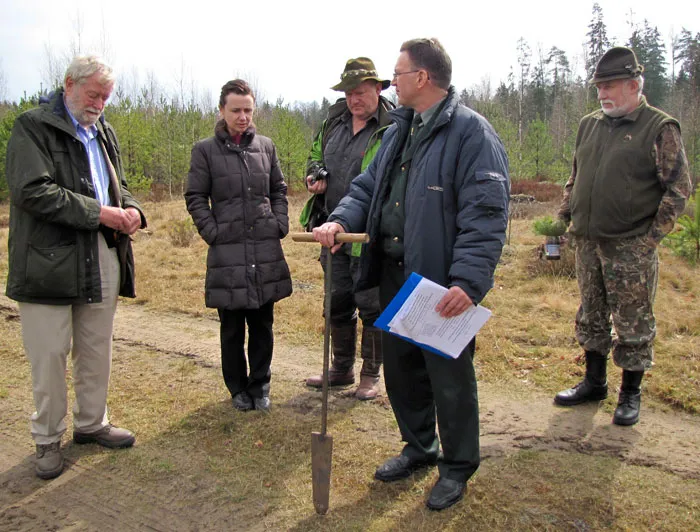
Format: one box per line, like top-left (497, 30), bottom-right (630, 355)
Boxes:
top-left (0, 194), bottom-right (700, 412)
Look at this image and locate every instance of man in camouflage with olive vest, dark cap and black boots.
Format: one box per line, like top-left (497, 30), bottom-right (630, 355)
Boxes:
top-left (554, 47), bottom-right (691, 425)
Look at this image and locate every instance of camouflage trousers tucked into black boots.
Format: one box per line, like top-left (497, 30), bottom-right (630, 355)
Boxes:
top-left (575, 236), bottom-right (659, 371)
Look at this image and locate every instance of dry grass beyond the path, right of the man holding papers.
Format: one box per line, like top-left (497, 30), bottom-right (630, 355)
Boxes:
top-left (479, 214), bottom-right (700, 413)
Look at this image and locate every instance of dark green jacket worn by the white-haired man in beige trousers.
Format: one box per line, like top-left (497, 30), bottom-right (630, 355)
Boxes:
top-left (6, 90), bottom-right (145, 305)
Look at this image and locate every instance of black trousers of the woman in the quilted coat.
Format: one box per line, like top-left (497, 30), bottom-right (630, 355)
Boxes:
top-left (218, 303), bottom-right (274, 397)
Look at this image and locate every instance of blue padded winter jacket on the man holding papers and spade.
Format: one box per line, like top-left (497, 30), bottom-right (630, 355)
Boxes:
top-left (328, 87), bottom-right (510, 303)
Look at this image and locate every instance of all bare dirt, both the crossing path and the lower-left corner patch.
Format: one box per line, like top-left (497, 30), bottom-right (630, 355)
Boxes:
top-left (0, 296), bottom-right (700, 530)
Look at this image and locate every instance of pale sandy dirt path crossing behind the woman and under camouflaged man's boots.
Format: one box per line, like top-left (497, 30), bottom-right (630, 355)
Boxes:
top-left (110, 305), bottom-right (700, 479)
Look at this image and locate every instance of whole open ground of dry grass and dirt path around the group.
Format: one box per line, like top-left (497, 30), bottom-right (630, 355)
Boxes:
top-left (0, 197), bottom-right (700, 531)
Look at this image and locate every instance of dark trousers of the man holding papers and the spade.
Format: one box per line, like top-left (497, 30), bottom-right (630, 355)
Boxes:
top-left (379, 260), bottom-right (479, 481)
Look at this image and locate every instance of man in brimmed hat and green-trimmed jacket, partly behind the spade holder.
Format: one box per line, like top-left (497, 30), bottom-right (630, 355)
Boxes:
top-left (302, 57), bottom-right (394, 400)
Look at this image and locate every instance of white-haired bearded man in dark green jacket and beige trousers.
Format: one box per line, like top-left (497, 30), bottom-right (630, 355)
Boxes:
top-left (7, 56), bottom-right (146, 479)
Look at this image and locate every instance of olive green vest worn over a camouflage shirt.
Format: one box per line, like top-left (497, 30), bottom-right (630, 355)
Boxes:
top-left (570, 97), bottom-right (680, 240)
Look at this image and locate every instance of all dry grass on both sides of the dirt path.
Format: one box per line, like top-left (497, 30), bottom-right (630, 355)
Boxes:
top-left (0, 196), bottom-right (700, 531)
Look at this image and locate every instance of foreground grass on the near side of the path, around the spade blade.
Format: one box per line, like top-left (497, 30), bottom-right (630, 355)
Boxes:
top-left (0, 308), bottom-right (700, 532)
